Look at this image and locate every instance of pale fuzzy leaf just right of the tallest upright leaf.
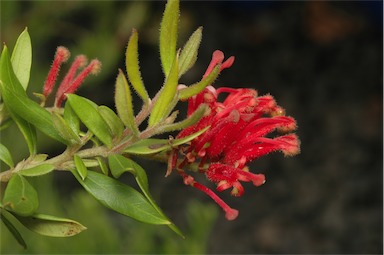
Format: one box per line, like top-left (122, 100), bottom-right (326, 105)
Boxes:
top-left (179, 27), bottom-right (203, 77)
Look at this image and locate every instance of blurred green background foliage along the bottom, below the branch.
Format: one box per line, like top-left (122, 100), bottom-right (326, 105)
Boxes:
top-left (0, 185), bottom-right (218, 254)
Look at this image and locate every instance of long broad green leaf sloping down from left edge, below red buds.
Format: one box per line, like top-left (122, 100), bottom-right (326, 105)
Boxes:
top-left (0, 46), bottom-right (66, 144)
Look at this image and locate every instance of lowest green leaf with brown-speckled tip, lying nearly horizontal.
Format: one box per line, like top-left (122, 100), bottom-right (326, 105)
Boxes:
top-left (17, 214), bottom-right (87, 237)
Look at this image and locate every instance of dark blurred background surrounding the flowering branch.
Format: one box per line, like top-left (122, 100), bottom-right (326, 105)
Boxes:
top-left (1, 1), bottom-right (383, 254)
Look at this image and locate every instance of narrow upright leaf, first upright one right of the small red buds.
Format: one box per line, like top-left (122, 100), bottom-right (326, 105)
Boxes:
top-left (115, 70), bottom-right (139, 135)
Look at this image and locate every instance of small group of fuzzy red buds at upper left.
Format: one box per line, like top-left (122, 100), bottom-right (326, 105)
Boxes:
top-left (43, 46), bottom-right (101, 107)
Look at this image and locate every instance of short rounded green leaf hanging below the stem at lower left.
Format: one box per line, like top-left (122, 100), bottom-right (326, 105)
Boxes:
top-left (3, 174), bottom-right (39, 216)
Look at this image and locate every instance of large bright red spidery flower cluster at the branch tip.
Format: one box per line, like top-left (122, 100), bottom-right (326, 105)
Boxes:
top-left (167, 51), bottom-right (300, 220)
